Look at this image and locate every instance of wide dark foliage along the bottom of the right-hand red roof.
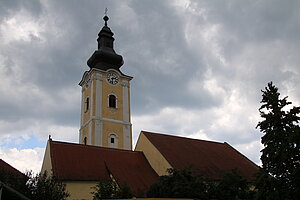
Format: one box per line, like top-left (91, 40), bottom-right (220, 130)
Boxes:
top-left (147, 169), bottom-right (253, 200)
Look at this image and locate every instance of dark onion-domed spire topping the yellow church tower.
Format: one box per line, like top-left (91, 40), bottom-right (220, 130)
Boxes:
top-left (87, 12), bottom-right (124, 71)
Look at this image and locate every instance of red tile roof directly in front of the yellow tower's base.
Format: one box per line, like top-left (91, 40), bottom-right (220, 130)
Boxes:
top-left (50, 140), bottom-right (158, 194)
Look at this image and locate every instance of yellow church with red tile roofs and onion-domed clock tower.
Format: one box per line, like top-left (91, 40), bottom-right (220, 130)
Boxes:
top-left (41, 16), bottom-right (258, 200)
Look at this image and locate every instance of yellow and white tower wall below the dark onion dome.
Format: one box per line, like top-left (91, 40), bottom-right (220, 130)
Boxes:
top-left (79, 69), bottom-right (132, 149)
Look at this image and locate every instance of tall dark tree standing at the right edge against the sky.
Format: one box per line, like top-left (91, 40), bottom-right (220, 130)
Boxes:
top-left (257, 82), bottom-right (300, 199)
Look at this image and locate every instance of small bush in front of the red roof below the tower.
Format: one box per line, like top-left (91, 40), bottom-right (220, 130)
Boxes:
top-left (92, 179), bottom-right (133, 200)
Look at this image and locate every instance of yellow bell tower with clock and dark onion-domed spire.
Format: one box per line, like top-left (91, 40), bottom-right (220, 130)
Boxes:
top-left (79, 15), bottom-right (132, 150)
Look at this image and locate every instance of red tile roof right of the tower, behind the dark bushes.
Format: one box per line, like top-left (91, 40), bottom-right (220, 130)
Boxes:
top-left (142, 131), bottom-right (258, 180)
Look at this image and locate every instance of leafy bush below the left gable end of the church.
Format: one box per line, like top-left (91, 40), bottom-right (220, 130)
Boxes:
top-left (27, 171), bottom-right (70, 200)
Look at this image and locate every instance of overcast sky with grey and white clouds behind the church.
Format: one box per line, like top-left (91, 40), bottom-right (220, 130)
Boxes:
top-left (0, 0), bottom-right (300, 172)
